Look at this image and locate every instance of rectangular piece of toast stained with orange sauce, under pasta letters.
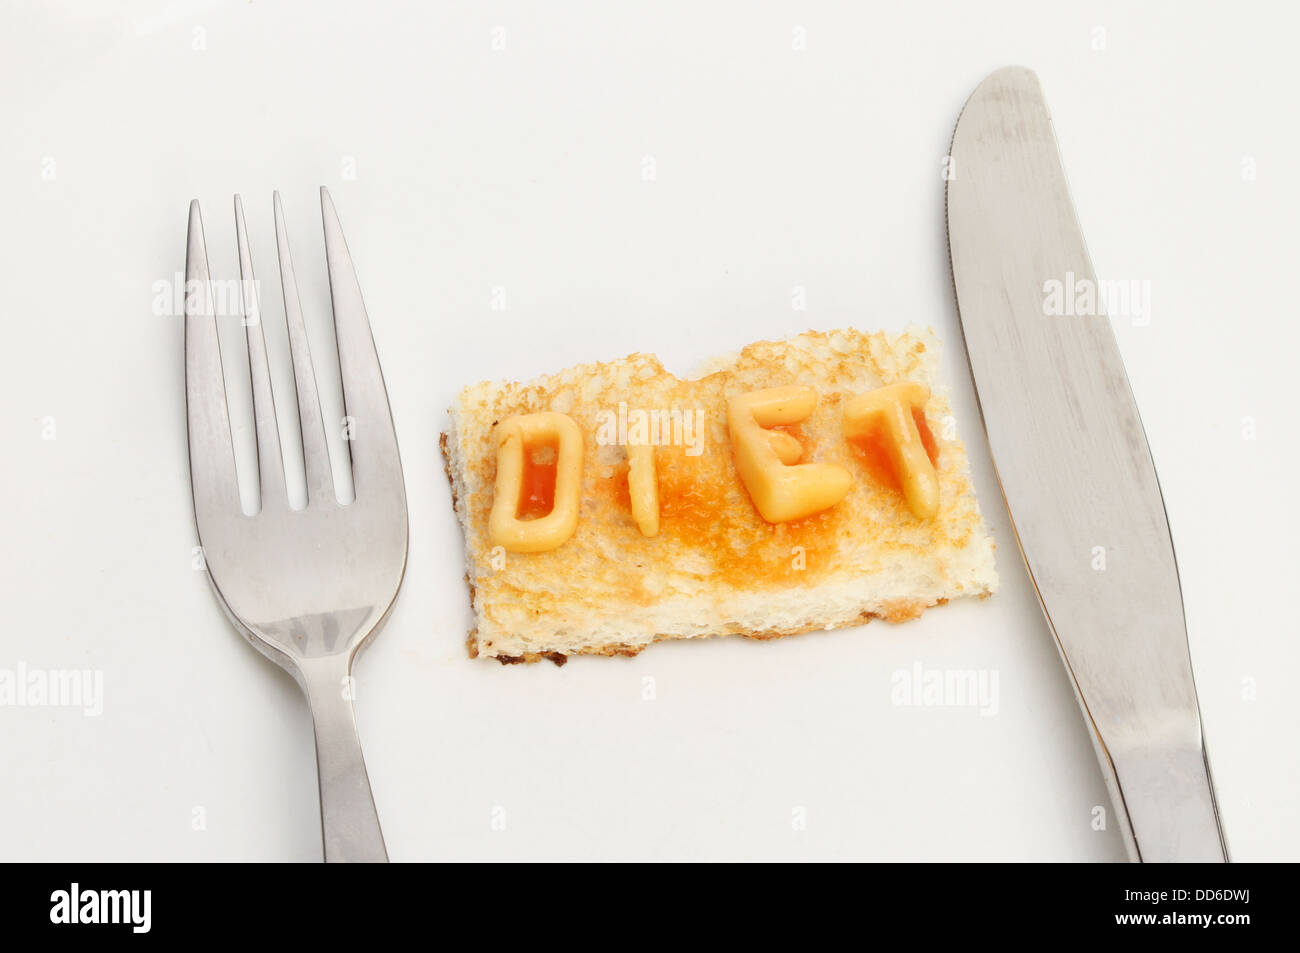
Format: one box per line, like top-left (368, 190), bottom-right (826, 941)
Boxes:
top-left (442, 330), bottom-right (997, 662)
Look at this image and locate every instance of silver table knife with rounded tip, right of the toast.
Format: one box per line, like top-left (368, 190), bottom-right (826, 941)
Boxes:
top-left (946, 66), bottom-right (1227, 862)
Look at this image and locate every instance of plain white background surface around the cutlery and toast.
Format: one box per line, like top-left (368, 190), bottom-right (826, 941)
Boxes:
top-left (0, 0), bottom-right (1300, 861)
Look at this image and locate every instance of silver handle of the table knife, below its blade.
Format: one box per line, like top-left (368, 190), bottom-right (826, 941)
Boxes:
top-left (1084, 728), bottom-right (1229, 863)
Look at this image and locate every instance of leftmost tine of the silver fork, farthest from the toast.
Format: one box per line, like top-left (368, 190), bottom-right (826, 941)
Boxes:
top-left (185, 199), bottom-right (239, 520)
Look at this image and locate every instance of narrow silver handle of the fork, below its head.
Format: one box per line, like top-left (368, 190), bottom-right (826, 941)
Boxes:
top-left (302, 658), bottom-right (389, 863)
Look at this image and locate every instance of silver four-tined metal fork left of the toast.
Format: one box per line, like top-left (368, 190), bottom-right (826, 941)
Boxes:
top-left (185, 187), bottom-right (407, 862)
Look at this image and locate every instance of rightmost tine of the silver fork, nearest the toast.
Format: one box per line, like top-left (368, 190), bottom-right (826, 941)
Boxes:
top-left (321, 186), bottom-right (403, 499)
